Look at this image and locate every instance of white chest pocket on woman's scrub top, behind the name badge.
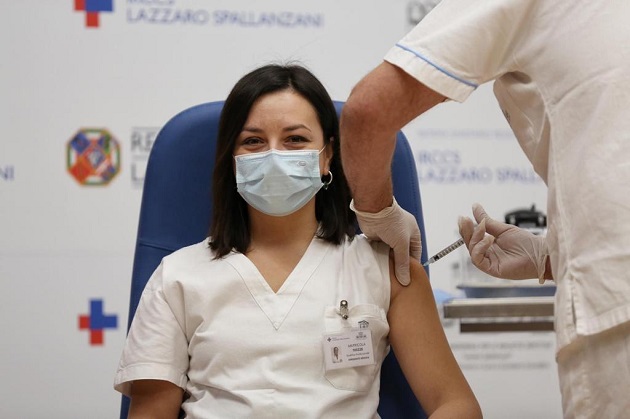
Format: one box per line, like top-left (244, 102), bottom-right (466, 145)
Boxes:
top-left (324, 304), bottom-right (389, 392)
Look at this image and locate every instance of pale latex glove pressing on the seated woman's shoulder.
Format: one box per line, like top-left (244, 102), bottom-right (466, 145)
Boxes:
top-left (350, 199), bottom-right (422, 286)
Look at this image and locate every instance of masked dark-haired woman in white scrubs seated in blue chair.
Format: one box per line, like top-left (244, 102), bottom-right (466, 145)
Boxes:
top-left (115, 65), bottom-right (481, 418)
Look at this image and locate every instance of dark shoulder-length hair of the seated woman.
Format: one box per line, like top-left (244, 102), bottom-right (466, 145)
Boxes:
top-left (209, 64), bottom-right (356, 258)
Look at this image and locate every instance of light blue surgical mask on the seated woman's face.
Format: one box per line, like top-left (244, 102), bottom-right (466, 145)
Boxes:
top-left (234, 147), bottom-right (325, 217)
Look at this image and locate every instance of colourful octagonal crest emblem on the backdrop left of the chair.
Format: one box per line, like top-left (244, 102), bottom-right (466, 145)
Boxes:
top-left (66, 128), bottom-right (120, 186)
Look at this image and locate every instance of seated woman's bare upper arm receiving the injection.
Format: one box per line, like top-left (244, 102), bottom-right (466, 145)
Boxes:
top-left (387, 257), bottom-right (482, 419)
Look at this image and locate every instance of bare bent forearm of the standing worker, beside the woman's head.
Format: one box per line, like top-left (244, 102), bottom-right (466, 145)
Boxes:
top-left (340, 62), bottom-right (444, 212)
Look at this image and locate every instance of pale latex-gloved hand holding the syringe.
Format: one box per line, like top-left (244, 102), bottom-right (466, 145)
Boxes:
top-left (458, 204), bottom-right (549, 282)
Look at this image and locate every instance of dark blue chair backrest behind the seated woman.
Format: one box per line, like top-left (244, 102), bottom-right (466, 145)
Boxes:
top-left (120, 102), bottom-right (427, 419)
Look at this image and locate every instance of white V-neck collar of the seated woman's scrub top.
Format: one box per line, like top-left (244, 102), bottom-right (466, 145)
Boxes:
top-left (225, 237), bottom-right (330, 330)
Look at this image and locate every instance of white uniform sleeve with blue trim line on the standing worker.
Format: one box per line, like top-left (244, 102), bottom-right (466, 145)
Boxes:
top-left (385, 0), bottom-right (538, 102)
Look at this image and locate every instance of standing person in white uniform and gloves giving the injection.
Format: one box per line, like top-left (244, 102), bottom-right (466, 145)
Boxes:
top-left (341, 0), bottom-right (630, 419)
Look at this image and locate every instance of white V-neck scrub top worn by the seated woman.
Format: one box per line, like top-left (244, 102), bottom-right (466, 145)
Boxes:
top-left (115, 236), bottom-right (390, 419)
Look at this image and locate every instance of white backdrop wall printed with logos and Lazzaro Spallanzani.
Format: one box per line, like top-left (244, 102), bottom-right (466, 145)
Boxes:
top-left (0, 0), bottom-right (560, 418)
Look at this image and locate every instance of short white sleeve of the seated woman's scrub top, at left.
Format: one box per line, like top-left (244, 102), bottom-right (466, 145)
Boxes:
top-left (114, 262), bottom-right (188, 396)
